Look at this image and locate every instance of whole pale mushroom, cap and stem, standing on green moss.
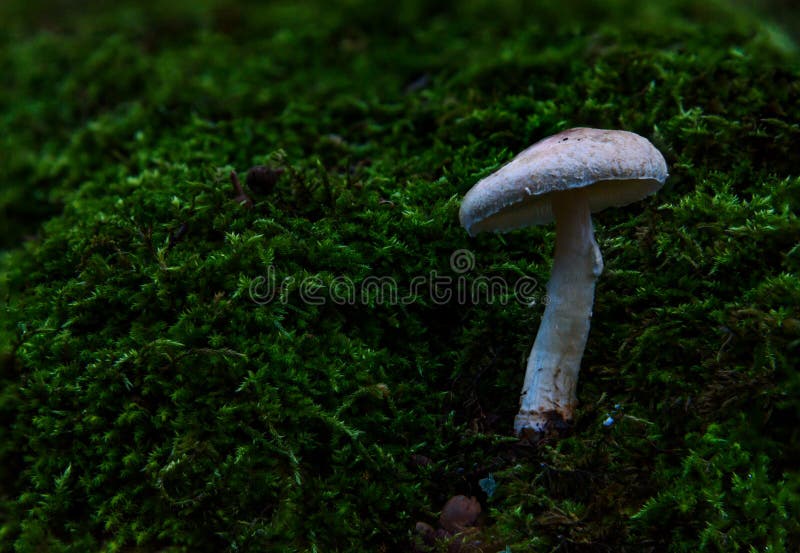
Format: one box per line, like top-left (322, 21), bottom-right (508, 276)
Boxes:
top-left (459, 128), bottom-right (667, 436)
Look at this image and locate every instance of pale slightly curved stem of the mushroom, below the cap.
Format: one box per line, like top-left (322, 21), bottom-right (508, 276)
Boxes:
top-left (514, 189), bottom-right (603, 435)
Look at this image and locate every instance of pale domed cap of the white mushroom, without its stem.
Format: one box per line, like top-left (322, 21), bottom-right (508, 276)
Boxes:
top-left (459, 127), bottom-right (668, 236)
